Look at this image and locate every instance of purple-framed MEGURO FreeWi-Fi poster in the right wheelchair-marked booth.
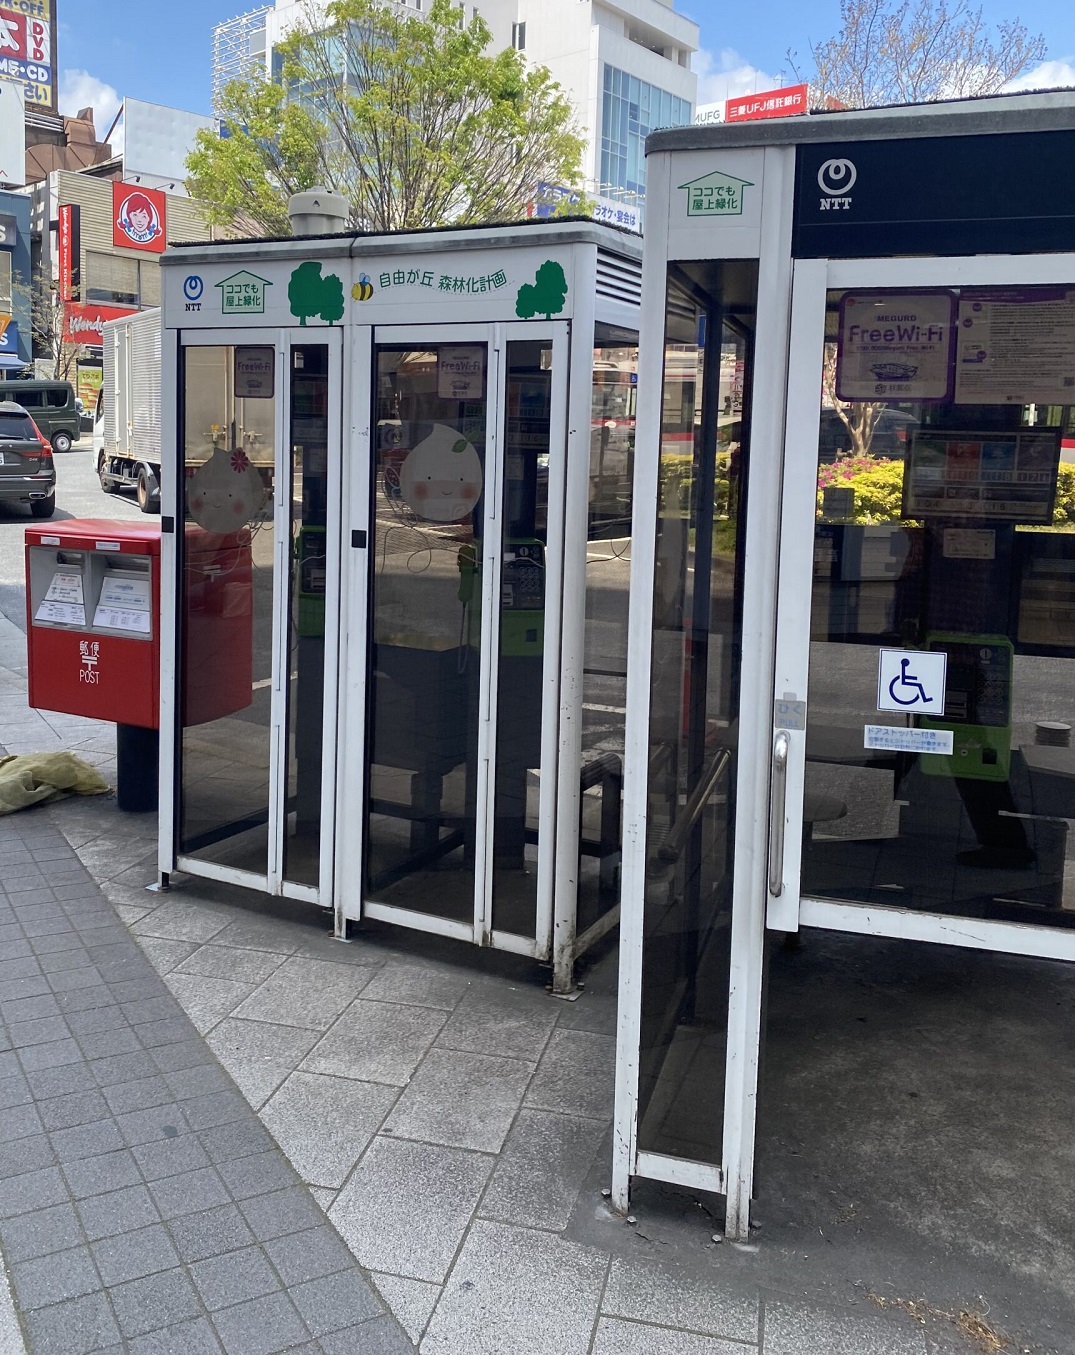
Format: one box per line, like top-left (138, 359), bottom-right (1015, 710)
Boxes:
top-left (836, 290), bottom-right (956, 400)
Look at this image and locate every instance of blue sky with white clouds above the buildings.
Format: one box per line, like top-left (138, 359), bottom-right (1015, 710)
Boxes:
top-left (56, 0), bottom-right (1075, 133)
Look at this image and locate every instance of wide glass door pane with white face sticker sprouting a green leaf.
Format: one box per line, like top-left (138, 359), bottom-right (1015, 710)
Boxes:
top-left (365, 344), bottom-right (487, 921)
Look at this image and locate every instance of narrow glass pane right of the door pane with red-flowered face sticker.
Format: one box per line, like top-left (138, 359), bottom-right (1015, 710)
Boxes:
top-left (283, 344), bottom-right (328, 885)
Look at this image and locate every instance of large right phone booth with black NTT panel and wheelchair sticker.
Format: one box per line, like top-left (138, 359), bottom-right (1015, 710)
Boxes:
top-left (613, 93), bottom-right (1075, 1237)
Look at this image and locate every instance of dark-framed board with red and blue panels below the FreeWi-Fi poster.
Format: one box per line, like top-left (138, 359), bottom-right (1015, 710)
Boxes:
top-left (903, 428), bottom-right (1060, 526)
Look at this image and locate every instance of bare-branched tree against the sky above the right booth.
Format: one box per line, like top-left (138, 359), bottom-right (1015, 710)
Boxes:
top-left (788, 0), bottom-right (1045, 108)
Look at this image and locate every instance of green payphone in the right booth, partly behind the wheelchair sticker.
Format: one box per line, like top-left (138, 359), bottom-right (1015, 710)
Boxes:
top-left (918, 634), bottom-right (1015, 782)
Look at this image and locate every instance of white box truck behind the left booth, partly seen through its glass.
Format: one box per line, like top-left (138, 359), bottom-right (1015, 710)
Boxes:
top-left (94, 309), bottom-right (274, 512)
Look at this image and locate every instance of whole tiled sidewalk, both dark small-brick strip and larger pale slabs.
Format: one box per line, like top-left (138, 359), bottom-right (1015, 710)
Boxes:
top-left (0, 618), bottom-right (931, 1355)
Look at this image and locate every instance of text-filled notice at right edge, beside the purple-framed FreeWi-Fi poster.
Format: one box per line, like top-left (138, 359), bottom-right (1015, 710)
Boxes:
top-left (956, 287), bottom-right (1075, 405)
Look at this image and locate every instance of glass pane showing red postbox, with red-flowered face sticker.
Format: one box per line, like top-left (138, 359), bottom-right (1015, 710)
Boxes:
top-left (179, 347), bottom-right (275, 875)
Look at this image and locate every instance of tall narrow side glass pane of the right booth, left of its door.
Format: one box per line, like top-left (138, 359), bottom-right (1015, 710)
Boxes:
top-left (638, 263), bottom-right (758, 1163)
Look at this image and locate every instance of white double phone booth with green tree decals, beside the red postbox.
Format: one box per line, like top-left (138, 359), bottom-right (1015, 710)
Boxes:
top-left (159, 221), bottom-right (641, 992)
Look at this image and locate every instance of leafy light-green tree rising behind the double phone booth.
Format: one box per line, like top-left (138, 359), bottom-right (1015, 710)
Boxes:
top-left (187, 0), bottom-right (584, 234)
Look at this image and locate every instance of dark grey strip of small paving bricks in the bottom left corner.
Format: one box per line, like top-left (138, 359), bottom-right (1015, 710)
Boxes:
top-left (0, 812), bottom-right (412, 1355)
